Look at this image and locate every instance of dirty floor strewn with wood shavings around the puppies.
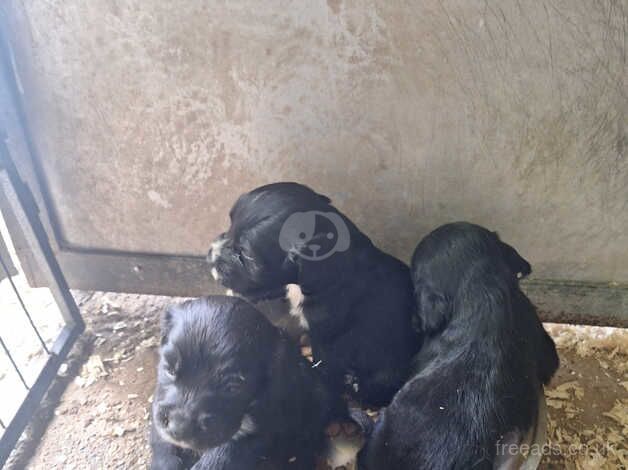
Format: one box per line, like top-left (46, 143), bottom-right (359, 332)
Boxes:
top-left (7, 292), bottom-right (628, 470)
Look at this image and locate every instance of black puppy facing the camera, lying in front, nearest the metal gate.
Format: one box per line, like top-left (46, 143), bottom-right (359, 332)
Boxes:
top-left (151, 296), bottom-right (347, 470)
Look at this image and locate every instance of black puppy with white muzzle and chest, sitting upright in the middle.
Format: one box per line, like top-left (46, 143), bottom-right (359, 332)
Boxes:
top-left (208, 183), bottom-right (420, 406)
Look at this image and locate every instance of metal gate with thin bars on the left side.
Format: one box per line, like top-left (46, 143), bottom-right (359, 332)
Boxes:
top-left (0, 139), bottom-right (84, 467)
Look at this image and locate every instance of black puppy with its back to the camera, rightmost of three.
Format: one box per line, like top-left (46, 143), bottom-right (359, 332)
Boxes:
top-left (359, 223), bottom-right (558, 470)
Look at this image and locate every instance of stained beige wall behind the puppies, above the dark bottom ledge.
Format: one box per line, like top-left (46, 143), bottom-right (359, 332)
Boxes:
top-left (2, 0), bottom-right (628, 282)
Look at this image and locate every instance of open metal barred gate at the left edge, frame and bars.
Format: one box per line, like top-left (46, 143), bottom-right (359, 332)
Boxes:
top-left (0, 137), bottom-right (84, 467)
